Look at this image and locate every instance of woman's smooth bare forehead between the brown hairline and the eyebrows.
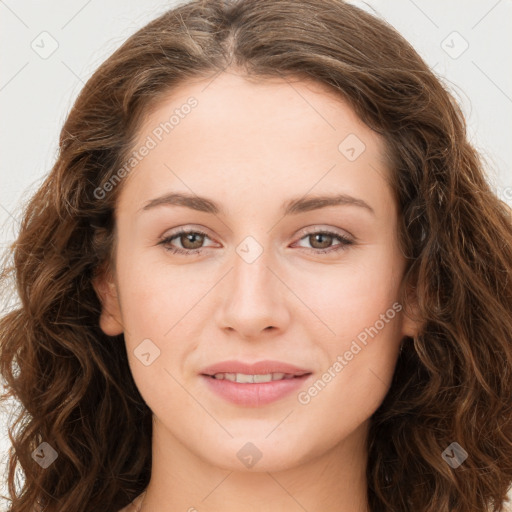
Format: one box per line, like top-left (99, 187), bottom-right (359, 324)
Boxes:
top-left (117, 72), bottom-right (392, 216)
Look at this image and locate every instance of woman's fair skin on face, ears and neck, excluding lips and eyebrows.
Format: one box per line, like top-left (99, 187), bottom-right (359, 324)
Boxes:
top-left (94, 71), bottom-right (417, 512)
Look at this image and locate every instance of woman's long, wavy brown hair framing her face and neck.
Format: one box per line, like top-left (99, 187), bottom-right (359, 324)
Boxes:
top-left (0, 0), bottom-right (512, 512)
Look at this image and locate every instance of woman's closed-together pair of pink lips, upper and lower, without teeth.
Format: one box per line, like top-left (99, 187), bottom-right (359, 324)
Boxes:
top-left (201, 361), bottom-right (313, 407)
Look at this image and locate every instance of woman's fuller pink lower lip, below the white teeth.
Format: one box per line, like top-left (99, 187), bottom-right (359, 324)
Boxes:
top-left (201, 373), bottom-right (312, 407)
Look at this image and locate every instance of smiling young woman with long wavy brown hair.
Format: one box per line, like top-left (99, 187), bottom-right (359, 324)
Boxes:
top-left (0, 0), bottom-right (512, 512)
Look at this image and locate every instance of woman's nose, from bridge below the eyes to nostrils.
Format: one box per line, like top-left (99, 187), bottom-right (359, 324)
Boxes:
top-left (217, 243), bottom-right (291, 339)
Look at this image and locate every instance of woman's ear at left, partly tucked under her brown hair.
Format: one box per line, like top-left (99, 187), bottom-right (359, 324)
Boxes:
top-left (92, 268), bottom-right (124, 336)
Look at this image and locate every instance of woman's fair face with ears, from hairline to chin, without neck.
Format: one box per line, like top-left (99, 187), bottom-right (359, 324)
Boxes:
top-left (95, 72), bottom-right (416, 471)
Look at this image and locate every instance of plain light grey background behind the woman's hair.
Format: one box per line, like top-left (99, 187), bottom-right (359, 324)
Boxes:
top-left (0, 0), bottom-right (512, 506)
